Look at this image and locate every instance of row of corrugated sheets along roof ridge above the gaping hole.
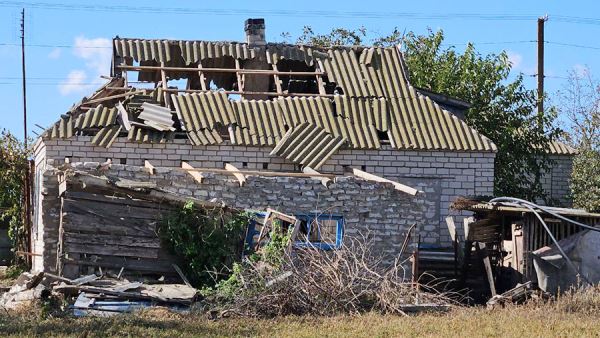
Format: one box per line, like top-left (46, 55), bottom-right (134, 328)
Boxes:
top-left (113, 39), bottom-right (259, 64)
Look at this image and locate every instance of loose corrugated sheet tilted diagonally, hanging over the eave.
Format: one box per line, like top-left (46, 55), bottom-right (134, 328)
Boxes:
top-left (271, 123), bottom-right (346, 170)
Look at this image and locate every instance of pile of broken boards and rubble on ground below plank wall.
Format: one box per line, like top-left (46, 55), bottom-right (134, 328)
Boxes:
top-left (0, 272), bottom-right (197, 316)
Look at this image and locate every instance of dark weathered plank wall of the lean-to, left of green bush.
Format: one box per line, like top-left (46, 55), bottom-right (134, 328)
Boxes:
top-left (57, 190), bottom-right (177, 278)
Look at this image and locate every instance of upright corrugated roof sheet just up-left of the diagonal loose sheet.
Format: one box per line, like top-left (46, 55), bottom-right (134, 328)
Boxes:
top-left (232, 100), bottom-right (286, 146)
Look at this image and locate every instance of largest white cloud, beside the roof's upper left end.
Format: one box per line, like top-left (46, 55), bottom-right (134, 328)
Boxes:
top-left (59, 36), bottom-right (112, 95)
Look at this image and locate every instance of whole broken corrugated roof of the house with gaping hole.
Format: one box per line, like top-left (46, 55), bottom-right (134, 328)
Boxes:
top-left (43, 22), bottom-right (496, 169)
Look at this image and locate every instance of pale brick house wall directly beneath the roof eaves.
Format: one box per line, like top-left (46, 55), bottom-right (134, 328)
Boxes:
top-left (32, 136), bottom-right (495, 245)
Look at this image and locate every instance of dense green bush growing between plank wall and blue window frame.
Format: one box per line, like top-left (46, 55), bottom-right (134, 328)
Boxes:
top-left (158, 202), bottom-right (250, 286)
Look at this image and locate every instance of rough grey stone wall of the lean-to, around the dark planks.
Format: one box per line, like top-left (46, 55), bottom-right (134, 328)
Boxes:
top-left (35, 162), bottom-right (425, 271)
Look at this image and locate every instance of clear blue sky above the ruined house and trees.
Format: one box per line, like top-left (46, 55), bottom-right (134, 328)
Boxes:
top-left (0, 0), bottom-right (600, 137)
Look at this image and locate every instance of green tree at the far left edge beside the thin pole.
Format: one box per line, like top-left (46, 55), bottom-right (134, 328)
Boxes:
top-left (0, 130), bottom-right (28, 262)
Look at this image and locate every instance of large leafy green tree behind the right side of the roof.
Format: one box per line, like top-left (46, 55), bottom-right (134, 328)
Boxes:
top-left (284, 27), bottom-right (560, 200)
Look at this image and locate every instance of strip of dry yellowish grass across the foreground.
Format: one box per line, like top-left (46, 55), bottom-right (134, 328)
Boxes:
top-left (0, 289), bottom-right (600, 337)
